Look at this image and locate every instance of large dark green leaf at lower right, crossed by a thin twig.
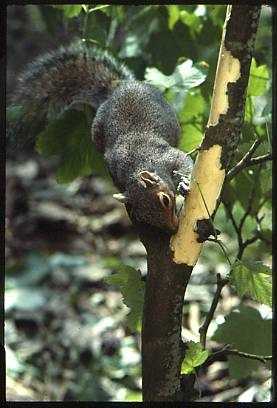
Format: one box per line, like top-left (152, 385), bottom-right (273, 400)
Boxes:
top-left (212, 305), bottom-right (272, 379)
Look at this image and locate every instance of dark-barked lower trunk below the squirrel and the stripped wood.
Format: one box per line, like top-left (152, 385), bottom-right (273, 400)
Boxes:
top-left (132, 220), bottom-right (192, 401)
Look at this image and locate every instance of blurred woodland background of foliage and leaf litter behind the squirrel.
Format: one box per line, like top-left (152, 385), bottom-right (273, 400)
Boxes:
top-left (5, 5), bottom-right (272, 402)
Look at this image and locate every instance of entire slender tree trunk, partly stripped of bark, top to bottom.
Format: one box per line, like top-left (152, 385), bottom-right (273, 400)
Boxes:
top-left (133, 5), bottom-right (260, 401)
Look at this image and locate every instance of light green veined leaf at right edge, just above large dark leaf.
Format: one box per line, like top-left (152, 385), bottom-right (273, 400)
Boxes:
top-left (230, 260), bottom-right (272, 306)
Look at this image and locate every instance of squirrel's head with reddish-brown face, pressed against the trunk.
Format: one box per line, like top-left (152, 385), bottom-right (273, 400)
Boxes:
top-left (114, 170), bottom-right (179, 233)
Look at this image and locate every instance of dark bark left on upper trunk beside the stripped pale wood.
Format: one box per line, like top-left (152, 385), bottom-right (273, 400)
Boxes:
top-left (201, 5), bottom-right (261, 168)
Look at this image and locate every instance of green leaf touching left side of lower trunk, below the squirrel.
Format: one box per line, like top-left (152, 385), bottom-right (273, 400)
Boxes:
top-left (104, 261), bottom-right (145, 331)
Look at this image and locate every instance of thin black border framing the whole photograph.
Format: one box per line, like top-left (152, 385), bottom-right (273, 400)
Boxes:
top-left (0, 0), bottom-right (277, 407)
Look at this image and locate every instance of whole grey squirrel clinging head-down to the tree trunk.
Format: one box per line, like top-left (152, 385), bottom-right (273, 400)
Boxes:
top-left (8, 42), bottom-right (193, 234)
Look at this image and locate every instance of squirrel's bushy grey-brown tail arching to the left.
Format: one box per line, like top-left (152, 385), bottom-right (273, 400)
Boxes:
top-left (7, 41), bottom-right (133, 150)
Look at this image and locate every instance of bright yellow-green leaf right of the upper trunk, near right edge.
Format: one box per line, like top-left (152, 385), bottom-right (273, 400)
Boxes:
top-left (247, 58), bottom-right (269, 96)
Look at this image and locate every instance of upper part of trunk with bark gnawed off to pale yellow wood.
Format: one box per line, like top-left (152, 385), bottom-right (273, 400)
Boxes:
top-left (171, 5), bottom-right (261, 266)
